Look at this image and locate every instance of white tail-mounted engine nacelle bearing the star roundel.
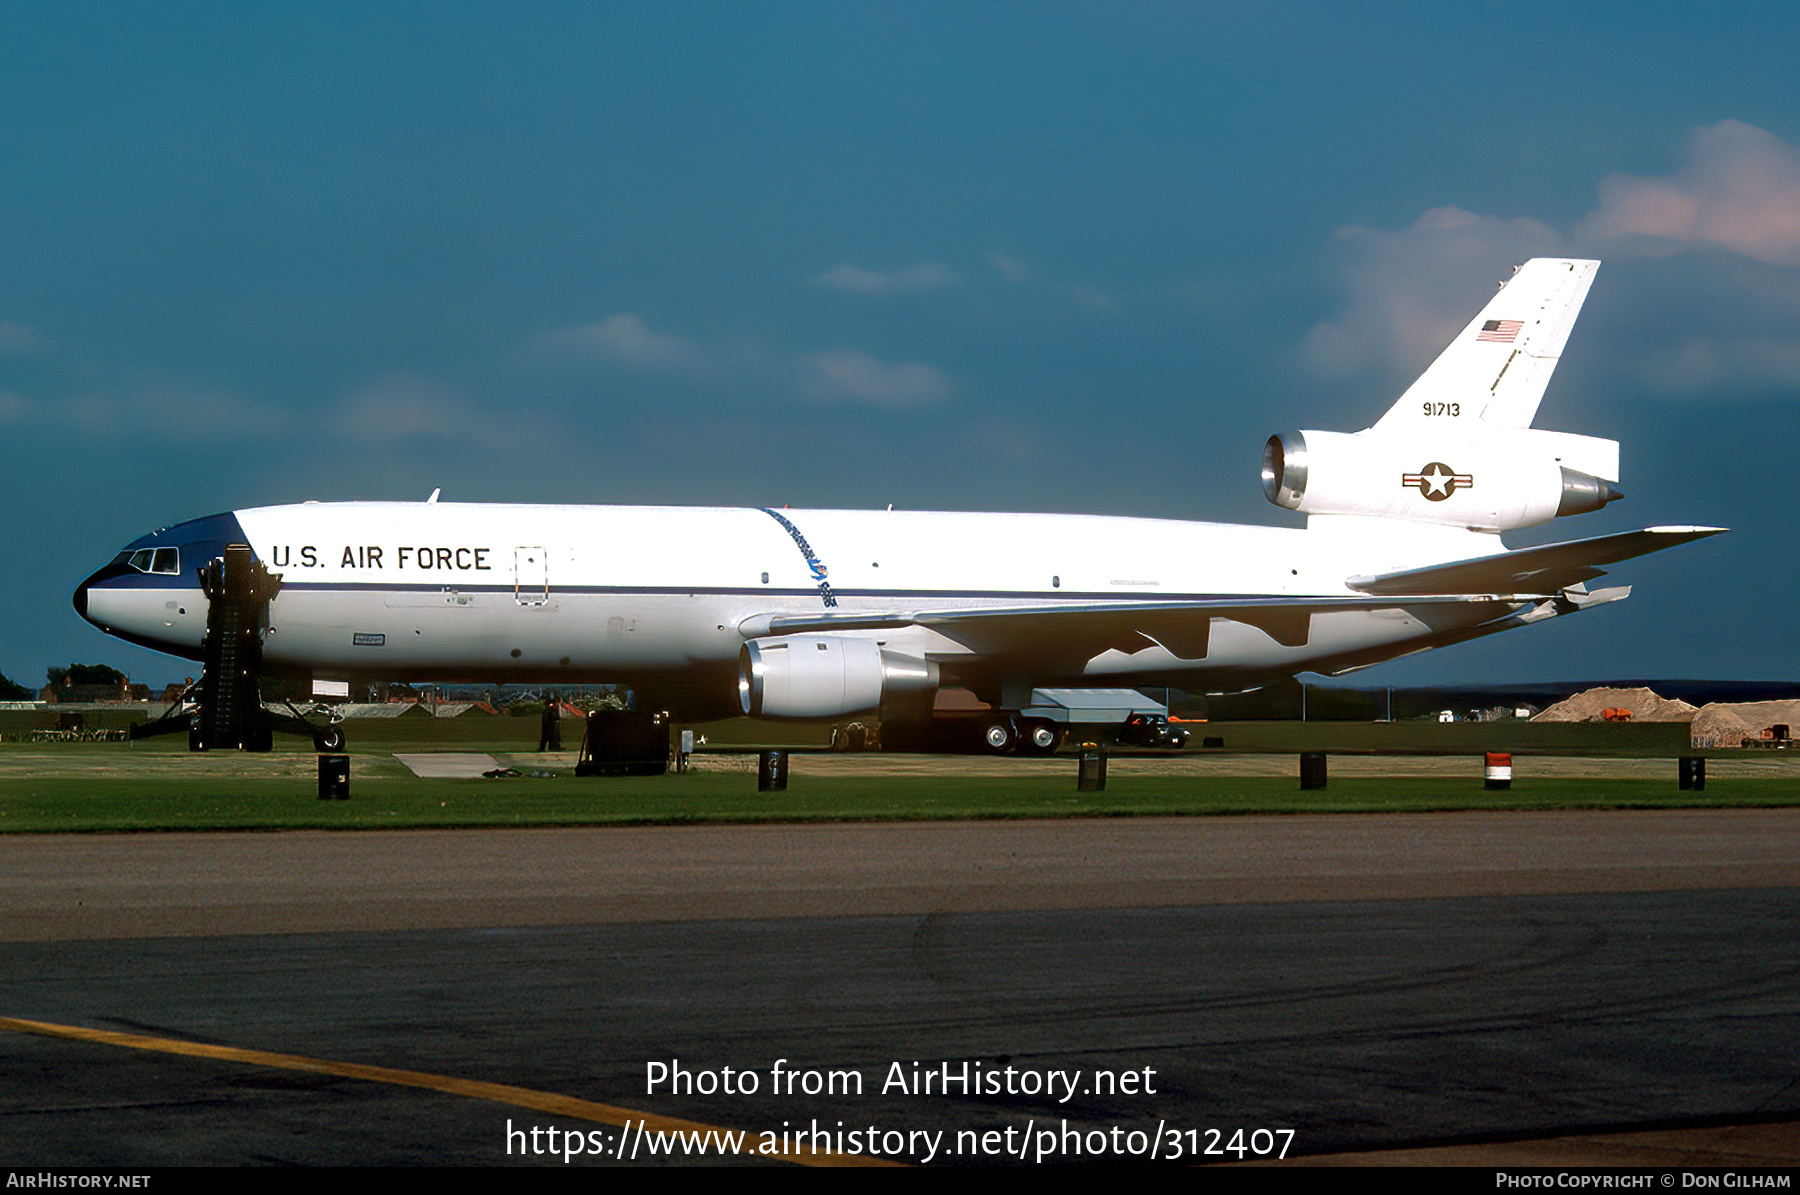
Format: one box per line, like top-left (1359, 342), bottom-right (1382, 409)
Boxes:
top-left (1262, 428), bottom-right (1625, 531)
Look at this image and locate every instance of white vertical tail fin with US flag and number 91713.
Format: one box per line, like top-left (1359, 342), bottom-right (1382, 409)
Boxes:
top-left (1373, 257), bottom-right (1600, 434)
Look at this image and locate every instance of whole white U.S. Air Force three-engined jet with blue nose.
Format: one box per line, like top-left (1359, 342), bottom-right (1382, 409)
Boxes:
top-left (74, 257), bottom-right (1723, 750)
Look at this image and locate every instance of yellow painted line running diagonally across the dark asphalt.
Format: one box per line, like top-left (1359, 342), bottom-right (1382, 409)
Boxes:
top-left (0, 1017), bottom-right (898, 1166)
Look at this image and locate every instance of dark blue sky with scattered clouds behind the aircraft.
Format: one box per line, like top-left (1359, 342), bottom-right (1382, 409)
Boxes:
top-left (0, 0), bottom-right (1800, 684)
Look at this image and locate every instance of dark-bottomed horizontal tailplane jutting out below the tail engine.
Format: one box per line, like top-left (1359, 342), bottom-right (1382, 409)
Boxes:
top-left (1345, 527), bottom-right (1724, 598)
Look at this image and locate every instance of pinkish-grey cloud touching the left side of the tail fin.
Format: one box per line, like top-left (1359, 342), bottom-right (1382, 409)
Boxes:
top-left (1301, 207), bottom-right (1562, 376)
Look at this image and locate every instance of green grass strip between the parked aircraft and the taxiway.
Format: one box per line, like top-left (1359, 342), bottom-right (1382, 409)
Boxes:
top-left (0, 740), bottom-right (1800, 833)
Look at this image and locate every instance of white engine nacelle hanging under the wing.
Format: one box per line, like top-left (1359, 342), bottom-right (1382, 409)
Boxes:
top-left (738, 635), bottom-right (938, 718)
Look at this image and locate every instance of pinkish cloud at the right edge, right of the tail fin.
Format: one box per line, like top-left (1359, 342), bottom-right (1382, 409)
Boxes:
top-left (1584, 121), bottom-right (1800, 266)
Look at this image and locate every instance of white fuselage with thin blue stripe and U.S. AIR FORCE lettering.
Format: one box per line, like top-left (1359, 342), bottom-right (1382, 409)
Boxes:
top-left (85, 502), bottom-right (1499, 712)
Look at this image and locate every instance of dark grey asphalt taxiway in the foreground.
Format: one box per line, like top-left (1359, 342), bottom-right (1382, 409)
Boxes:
top-left (0, 810), bottom-right (1800, 1166)
